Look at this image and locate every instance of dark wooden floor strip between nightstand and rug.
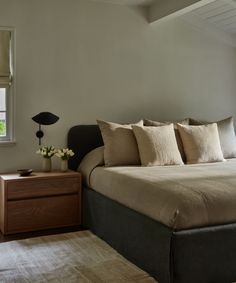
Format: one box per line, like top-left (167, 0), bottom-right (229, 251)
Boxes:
top-left (0, 226), bottom-right (85, 243)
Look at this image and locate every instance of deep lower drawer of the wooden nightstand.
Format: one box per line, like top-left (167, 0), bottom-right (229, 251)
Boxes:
top-left (6, 195), bottom-right (80, 233)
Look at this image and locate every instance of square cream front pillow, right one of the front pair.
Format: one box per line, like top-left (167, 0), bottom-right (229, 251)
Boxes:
top-left (178, 123), bottom-right (224, 164)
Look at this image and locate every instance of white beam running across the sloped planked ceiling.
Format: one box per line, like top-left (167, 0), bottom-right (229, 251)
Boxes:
top-left (148, 0), bottom-right (216, 23)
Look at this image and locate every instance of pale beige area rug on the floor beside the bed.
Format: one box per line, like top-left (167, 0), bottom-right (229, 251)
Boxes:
top-left (0, 231), bottom-right (156, 283)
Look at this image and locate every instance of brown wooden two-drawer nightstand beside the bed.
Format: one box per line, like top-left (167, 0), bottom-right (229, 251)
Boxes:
top-left (0, 171), bottom-right (81, 234)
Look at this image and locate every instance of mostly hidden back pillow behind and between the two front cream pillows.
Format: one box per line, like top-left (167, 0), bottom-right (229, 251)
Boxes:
top-left (143, 118), bottom-right (189, 162)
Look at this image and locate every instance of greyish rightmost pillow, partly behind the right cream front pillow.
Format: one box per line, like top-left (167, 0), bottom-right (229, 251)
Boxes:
top-left (190, 117), bottom-right (236, 158)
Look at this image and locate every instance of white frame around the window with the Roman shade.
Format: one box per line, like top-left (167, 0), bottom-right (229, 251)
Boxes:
top-left (0, 26), bottom-right (16, 146)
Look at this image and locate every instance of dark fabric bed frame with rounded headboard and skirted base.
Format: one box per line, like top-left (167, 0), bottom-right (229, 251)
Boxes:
top-left (68, 125), bottom-right (236, 283)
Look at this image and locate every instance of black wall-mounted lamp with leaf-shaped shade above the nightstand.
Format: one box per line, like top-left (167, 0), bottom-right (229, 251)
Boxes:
top-left (32, 112), bottom-right (59, 145)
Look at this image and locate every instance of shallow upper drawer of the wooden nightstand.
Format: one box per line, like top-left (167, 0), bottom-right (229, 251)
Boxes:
top-left (7, 177), bottom-right (79, 200)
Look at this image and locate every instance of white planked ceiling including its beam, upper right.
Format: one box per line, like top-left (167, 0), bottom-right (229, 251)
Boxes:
top-left (89, 0), bottom-right (236, 46)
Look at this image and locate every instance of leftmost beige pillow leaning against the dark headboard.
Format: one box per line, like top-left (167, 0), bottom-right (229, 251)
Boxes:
top-left (97, 120), bottom-right (143, 166)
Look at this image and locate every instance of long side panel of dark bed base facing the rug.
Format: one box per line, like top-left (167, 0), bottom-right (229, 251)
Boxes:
top-left (83, 188), bottom-right (172, 282)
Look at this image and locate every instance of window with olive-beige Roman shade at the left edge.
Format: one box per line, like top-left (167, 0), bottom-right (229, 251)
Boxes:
top-left (0, 27), bottom-right (14, 144)
